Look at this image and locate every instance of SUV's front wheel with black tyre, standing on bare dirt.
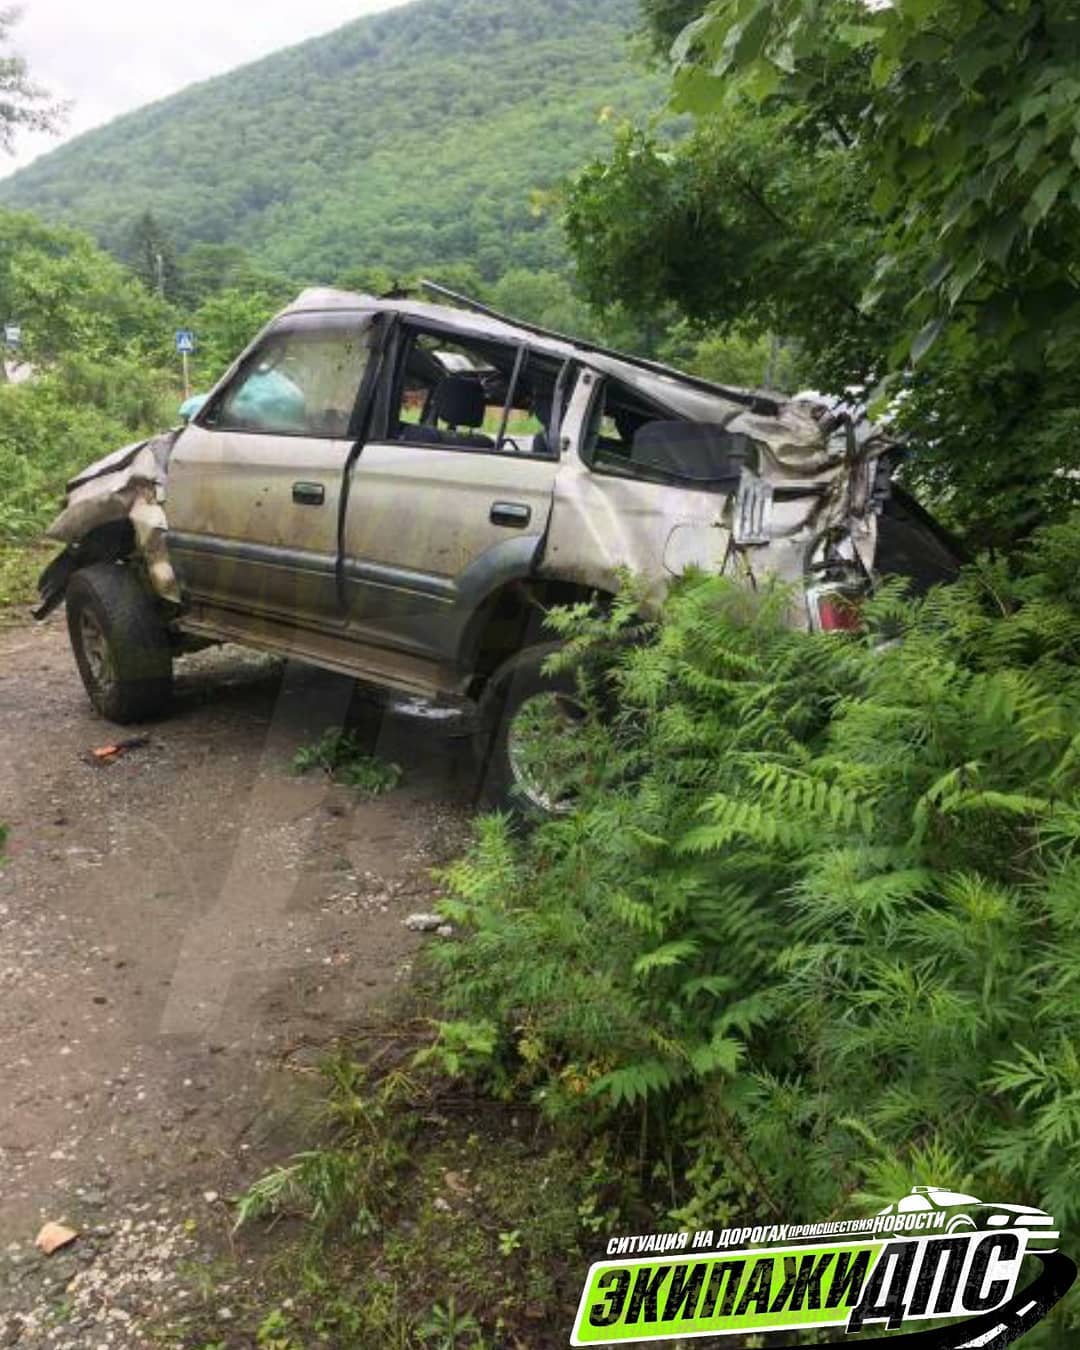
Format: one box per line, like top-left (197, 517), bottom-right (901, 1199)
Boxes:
top-left (68, 563), bottom-right (173, 722)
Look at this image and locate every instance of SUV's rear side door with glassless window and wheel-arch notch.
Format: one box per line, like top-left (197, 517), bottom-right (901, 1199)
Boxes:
top-left (343, 329), bottom-right (562, 662)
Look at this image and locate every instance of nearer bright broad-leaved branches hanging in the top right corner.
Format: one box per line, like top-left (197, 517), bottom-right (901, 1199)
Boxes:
top-left (674, 0), bottom-right (1080, 360)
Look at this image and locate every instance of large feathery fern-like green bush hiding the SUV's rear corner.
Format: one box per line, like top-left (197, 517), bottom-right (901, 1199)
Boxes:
top-left (432, 521), bottom-right (1080, 1334)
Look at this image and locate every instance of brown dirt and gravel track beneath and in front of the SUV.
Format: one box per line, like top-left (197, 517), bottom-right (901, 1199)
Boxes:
top-left (0, 616), bottom-right (471, 1350)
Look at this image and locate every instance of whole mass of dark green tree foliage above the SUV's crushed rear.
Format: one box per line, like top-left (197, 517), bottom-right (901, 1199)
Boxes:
top-left (567, 0), bottom-right (1080, 544)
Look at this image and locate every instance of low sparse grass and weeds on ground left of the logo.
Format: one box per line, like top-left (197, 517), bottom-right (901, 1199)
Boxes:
top-left (205, 990), bottom-right (631, 1350)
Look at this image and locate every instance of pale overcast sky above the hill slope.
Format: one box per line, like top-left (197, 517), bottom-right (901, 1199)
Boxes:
top-left (0, 0), bottom-right (400, 177)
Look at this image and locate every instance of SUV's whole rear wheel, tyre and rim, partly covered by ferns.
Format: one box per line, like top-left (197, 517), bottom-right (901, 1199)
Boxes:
top-left (477, 643), bottom-right (587, 824)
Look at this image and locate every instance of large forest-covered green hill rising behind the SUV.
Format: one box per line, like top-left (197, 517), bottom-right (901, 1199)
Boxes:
top-left (0, 0), bottom-right (663, 279)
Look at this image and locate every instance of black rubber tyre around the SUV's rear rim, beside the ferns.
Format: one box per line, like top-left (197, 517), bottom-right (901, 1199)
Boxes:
top-left (474, 643), bottom-right (583, 824)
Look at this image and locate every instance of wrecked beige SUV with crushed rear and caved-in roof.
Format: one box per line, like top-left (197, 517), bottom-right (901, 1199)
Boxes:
top-left (36, 288), bottom-right (952, 811)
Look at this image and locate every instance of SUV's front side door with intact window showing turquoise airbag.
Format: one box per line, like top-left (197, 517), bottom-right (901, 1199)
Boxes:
top-left (167, 312), bottom-right (377, 628)
